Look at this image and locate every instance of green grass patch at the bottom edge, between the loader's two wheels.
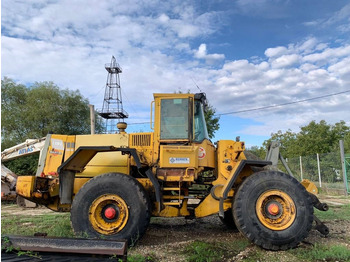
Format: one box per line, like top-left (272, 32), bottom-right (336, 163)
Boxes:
top-left (183, 239), bottom-right (249, 262)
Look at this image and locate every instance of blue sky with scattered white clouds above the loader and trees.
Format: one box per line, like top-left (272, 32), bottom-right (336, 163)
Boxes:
top-left (1, 0), bottom-right (350, 147)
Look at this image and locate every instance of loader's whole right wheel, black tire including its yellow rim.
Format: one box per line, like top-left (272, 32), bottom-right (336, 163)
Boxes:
top-left (233, 171), bottom-right (313, 250)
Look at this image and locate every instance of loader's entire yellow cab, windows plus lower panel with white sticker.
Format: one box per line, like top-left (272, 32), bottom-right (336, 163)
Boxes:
top-left (153, 93), bottom-right (215, 174)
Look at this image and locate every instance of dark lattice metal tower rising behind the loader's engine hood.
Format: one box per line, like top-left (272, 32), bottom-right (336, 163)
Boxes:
top-left (98, 56), bottom-right (128, 134)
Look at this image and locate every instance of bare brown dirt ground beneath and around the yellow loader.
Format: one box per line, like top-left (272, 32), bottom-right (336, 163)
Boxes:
top-left (1, 197), bottom-right (350, 262)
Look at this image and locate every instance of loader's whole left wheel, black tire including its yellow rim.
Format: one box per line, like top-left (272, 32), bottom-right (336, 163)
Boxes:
top-left (71, 173), bottom-right (151, 245)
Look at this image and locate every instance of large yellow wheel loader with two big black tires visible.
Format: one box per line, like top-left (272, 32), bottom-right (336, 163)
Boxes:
top-left (16, 93), bottom-right (328, 250)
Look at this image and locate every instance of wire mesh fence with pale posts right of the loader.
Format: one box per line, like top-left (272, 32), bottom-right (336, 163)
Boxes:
top-left (278, 152), bottom-right (350, 195)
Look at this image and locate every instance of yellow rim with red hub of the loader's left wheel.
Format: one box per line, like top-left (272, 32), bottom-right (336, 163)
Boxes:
top-left (89, 194), bottom-right (129, 235)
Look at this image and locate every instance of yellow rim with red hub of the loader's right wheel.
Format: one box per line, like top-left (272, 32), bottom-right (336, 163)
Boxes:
top-left (256, 190), bottom-right (296, 230)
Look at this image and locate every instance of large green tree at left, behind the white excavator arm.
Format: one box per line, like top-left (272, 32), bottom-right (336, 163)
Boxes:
top-left (1, 77), bottom-right (104, 174)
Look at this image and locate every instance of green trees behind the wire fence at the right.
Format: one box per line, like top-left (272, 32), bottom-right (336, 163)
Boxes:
top-left (264, 120), bottom-right (350, 182)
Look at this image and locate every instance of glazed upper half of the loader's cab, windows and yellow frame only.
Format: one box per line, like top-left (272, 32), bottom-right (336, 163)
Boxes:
top-left (154, 93), bottom-right (209, 144)
